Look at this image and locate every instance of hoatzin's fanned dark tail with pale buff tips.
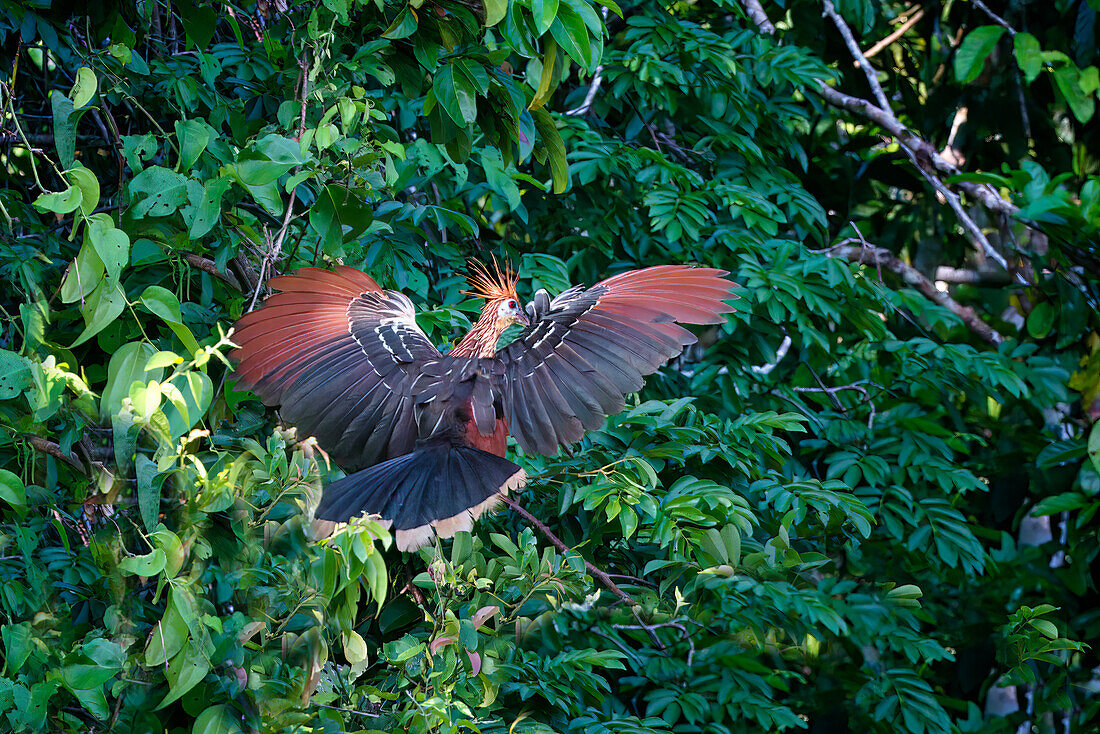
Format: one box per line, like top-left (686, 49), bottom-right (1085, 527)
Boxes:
top-left (315, 443), bottom-right (527, 550)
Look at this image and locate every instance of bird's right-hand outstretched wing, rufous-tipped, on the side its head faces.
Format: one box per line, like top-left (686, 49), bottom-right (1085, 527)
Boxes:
top-left (494, 265), bottom-right (734, 454)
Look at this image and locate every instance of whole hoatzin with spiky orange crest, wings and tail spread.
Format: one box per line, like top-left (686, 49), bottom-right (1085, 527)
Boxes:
top-left (232, 264), bottom-right (733, 550)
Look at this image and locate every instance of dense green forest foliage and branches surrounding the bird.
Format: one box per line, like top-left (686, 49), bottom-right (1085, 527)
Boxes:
top-left (0, 0), bottom-right (1100, 734)
